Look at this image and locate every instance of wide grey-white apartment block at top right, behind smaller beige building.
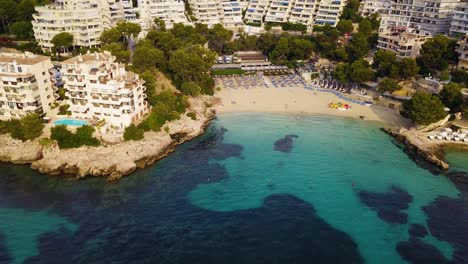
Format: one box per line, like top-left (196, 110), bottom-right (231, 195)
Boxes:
top-left (379, 0), bottom-right (460, 35)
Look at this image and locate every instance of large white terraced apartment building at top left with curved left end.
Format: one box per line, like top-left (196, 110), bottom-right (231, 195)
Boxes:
top-left (32, 0), bottom-right (136, 51)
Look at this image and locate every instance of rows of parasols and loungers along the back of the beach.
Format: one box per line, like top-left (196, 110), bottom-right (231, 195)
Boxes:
top-left (216, 74), bottom-right (372, 105)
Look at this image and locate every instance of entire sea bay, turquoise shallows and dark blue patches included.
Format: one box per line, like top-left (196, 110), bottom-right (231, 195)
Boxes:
top-left (0, 114), bottom-right (468, 264)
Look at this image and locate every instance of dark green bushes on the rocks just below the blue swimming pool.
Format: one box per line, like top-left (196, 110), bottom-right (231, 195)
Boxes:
top-left (50, 125), bottom-right (100, 149)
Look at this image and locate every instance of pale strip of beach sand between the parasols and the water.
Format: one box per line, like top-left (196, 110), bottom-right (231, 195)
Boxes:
top-left (215, 86), bottom-right (409, 127)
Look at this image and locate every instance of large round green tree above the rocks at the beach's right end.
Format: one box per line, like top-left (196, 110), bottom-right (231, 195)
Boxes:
top-left (403, 91), bottom-right (446, 125)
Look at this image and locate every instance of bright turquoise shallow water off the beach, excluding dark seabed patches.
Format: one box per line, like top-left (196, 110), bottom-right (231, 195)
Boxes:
top-left (188, 115), bottom-right (458, 263)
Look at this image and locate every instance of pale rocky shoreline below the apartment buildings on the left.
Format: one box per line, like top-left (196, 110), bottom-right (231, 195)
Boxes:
top-left (0, 96), bottom-right (216, 181)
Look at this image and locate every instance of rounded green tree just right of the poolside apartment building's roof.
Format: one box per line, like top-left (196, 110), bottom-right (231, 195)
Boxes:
top-left (133, 46), bottom-right (165, 71)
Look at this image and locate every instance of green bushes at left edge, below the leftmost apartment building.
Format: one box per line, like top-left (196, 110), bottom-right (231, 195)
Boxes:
top-left (0, 114), bottom-right (44, 141)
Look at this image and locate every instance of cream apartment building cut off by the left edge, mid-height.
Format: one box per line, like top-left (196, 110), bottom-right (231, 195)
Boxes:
top-left (0, 52), bottom-right (56, 119)
